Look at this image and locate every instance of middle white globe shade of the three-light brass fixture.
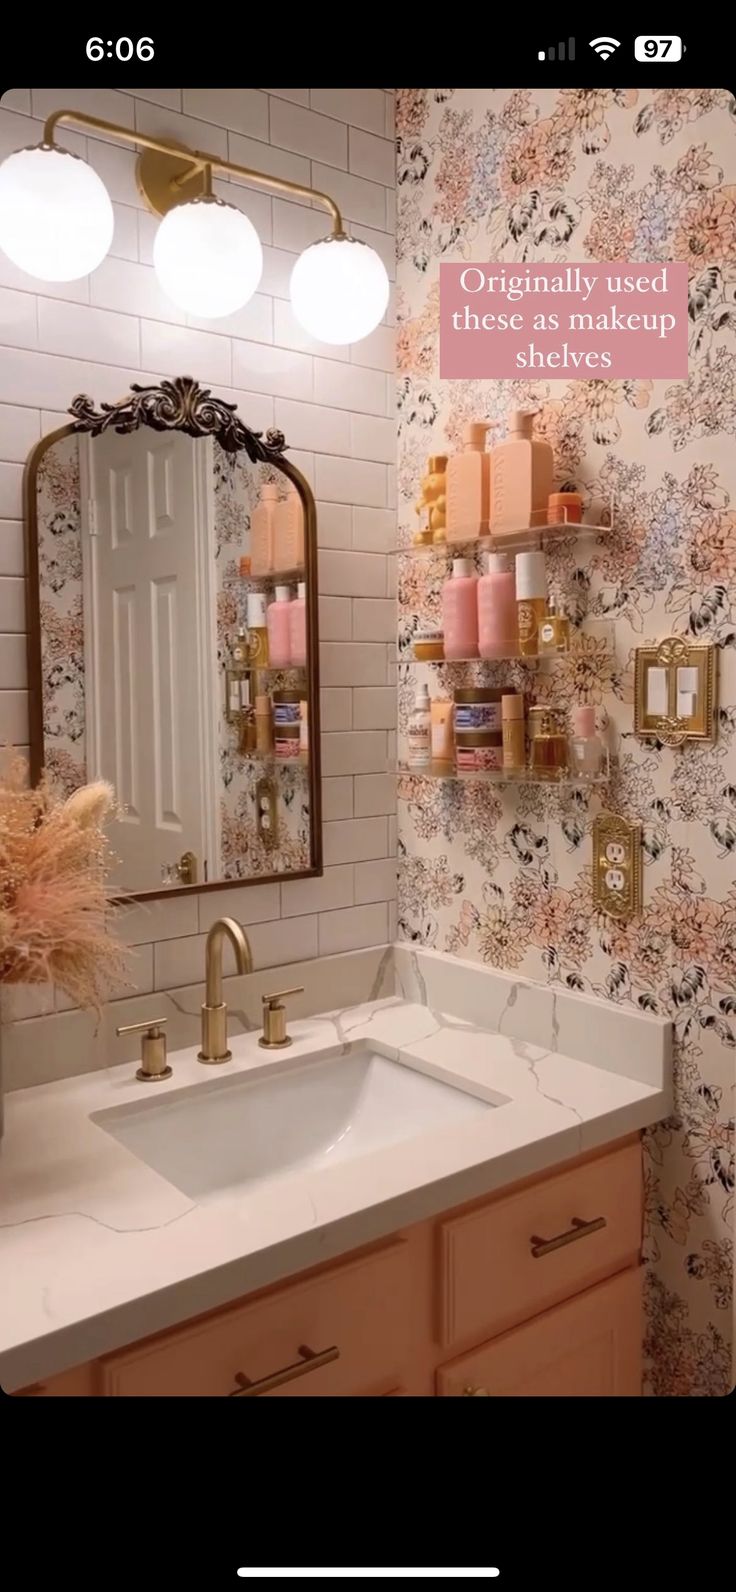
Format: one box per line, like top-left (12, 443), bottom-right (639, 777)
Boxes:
top-left (153, 194), bottom-right (263, 320)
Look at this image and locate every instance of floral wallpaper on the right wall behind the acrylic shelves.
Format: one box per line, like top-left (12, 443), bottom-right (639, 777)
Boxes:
top-left (397, 89), bottom-right (736, 1396)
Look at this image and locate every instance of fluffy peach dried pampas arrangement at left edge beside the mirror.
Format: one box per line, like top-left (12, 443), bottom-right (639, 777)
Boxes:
top-left (0, 758), bottom-right (127, 1011)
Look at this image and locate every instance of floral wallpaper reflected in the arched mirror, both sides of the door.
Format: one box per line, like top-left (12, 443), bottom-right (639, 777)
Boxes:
top-left (37, 436), bottom-right (311, 879)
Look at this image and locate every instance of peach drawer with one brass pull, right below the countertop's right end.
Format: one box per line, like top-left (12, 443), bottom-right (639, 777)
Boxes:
top-left (440, 1141), bottom-right (642, 1347)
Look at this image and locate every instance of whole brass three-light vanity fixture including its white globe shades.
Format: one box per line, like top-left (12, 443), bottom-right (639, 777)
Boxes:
top-left (0, 110), bottom-right (389, 344)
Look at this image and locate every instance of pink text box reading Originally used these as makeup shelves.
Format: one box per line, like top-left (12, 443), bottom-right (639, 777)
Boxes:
top-left (440, 261), bottom-right (688, 380)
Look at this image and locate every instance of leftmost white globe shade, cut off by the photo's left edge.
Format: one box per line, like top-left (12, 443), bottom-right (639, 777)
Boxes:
top-left (0, 143), bottom-right (115, 282)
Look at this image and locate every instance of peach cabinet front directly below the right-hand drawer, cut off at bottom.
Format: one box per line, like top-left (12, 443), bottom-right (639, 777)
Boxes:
top-left (437, 1267), bottom-right (642, 1398)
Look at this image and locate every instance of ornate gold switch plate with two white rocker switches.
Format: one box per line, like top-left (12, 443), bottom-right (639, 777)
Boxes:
top-left (634, 635), bottom-right (717, 747)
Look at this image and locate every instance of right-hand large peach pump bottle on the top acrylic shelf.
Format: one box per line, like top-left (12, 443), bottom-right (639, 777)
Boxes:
top-left (491, 409), bottom-right (554, 535)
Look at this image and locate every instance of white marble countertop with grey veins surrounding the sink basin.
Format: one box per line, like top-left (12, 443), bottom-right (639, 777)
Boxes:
top-left (0, 958), bottom-right (669, 1391)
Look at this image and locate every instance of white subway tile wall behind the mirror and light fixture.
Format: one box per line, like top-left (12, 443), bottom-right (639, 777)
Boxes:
top-left (0, 89), bottom-right (397, 1083)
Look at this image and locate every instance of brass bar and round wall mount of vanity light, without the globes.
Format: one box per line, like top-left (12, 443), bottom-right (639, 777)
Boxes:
top-left (43, 110), bottom-right (346, 237)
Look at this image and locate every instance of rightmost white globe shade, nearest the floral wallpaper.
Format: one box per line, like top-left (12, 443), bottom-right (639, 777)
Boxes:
top-left (292, 237), bottom-right (389, 342)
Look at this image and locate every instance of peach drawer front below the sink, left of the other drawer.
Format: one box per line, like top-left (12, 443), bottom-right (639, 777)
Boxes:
top-left (100, 1240), bottom-right (411, 1398)
